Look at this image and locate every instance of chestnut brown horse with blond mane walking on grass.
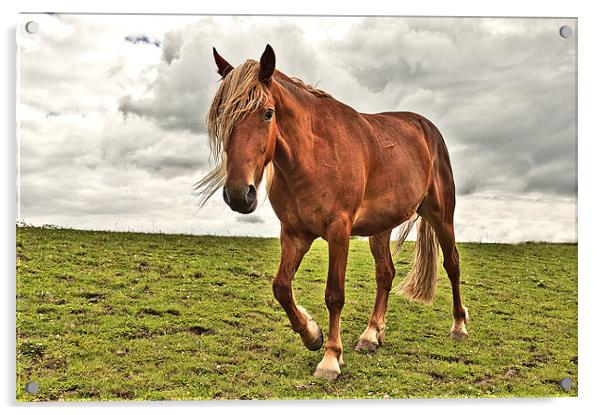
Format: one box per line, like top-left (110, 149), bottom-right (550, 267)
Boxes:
top-left (196, 45), bottom-right (468, 380)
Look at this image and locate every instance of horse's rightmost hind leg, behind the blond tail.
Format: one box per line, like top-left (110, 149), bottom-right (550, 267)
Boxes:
top-left (420, 202), bottom-right (468, 340)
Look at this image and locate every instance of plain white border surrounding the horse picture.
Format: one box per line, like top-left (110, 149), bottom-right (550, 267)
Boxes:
top-left (0, 0), bottom-right (602, 415)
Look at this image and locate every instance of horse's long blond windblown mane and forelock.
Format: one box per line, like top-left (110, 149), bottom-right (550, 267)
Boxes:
top-left (193, 59), bottom-right (332, 206)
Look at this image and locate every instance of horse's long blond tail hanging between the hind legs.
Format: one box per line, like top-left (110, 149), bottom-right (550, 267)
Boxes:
top-left (393, 215), bottom-right (439, 304)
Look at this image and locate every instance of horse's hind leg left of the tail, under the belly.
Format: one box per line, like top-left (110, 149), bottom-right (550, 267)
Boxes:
top-left (355, 229), bottom-right (395, 352)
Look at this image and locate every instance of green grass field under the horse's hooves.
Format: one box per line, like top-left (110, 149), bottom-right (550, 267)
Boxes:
top-left (17, 228), bottom-right (577, 401)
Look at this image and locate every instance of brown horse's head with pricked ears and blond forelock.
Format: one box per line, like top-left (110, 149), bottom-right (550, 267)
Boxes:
top-left (202, 45), bottom-right (277, 213)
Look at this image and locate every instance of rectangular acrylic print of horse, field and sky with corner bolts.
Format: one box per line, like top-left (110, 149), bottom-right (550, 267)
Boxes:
top-left (16, 14), bottom-right (578, 401)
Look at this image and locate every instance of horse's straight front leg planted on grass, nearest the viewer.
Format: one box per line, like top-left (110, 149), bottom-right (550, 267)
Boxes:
top-left (314, 220), bottom-right (351, 380)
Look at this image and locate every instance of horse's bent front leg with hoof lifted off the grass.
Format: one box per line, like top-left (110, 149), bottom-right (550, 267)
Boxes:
top-left (272, 225), bottom-right (323, 350)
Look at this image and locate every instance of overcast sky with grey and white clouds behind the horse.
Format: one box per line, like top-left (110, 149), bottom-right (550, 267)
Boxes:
top-left (17, 15), bottom-right (577, 242)
